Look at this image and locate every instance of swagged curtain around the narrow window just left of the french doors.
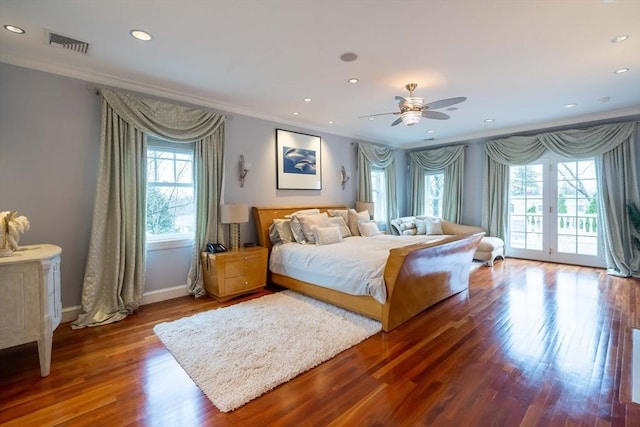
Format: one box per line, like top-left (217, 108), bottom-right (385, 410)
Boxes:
top-left (409, 145), bottom-right (464, 223)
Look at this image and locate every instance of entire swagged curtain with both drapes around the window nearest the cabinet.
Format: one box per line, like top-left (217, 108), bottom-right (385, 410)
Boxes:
top-left (72, 89), bottom-right (224, 328)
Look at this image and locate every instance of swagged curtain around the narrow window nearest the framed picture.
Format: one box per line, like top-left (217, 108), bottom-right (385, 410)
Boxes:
top-left (357, 144), bottom-right (398, 230)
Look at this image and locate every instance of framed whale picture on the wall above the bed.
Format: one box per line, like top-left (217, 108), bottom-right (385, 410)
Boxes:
top-left (276, 129), bottom-right (322, 190)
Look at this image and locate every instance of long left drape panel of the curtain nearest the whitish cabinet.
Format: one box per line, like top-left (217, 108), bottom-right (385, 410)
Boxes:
top-left (71, 99), bottom-right (147, 329)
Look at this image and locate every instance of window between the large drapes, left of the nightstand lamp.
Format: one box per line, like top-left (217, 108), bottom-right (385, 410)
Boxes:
top-left (146, 138), bottom-right (195, 248)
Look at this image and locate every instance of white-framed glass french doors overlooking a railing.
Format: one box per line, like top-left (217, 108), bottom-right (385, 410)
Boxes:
top-left (505, 159), bottom-right (604, 267)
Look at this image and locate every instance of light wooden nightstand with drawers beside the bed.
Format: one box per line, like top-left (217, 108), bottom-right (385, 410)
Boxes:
top-left (200, 246), bottom-right (269, 301)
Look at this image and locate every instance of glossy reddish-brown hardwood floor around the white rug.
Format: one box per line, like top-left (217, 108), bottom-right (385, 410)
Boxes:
top-left (0, 259), bottom-right (640, 426)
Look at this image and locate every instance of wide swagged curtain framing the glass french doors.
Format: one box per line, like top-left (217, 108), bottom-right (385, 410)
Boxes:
top-left (482, 118), bottom-right (640, 276)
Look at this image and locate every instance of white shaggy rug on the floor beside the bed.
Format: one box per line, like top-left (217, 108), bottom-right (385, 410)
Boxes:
top-left (153, 291), bottom-right (382, 412)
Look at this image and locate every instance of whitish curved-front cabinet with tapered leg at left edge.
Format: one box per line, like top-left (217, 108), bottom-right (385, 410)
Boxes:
top-left (0, 244), bottom-right (62, 377)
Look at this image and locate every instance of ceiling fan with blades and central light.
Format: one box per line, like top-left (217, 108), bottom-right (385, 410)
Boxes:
top-left (359, 83), bottom-right (467, 126)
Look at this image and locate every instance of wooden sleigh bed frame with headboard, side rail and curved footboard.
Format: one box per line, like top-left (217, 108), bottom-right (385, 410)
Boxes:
top-left (252, 206), bottom-right (484, 331)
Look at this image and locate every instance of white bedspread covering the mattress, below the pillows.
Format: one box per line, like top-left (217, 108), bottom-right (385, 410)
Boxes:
top-left (269, 235), bottom-right (446, 304)
